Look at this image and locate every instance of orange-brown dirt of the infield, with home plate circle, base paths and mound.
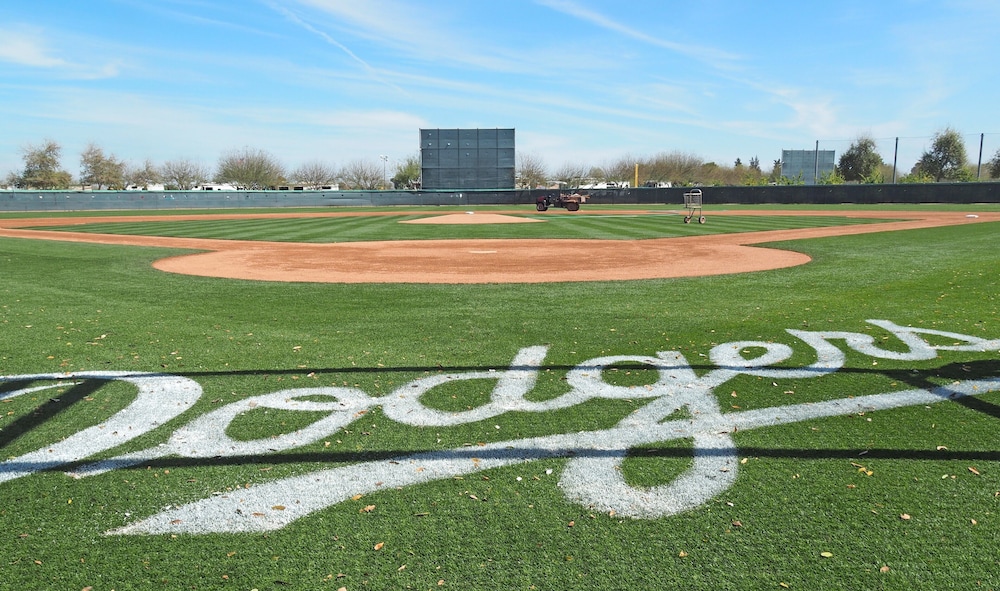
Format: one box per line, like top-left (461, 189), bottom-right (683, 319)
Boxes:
top-left (0, 211), bottom-right (1000, 284)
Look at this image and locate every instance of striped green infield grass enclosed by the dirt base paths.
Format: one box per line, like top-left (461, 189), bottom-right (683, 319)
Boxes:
top-left (33, 214), bottom-right (884, 243)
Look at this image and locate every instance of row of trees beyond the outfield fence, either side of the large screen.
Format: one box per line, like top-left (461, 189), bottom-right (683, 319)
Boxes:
top-left (3, 128), bottom-right (1000, 191)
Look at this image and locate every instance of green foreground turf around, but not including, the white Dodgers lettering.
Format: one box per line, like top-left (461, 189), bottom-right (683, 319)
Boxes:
top-left (0, 209), bottom-right (1000, 591)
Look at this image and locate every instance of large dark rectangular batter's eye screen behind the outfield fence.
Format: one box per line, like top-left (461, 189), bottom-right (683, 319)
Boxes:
top-left (420, 129), bottom-right (515, 189)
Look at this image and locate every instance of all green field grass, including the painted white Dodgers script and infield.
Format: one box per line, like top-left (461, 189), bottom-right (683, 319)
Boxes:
top-left (0, 208), bottom-right (1000, 591)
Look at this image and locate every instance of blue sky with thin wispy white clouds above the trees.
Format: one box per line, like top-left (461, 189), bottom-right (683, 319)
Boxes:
top-left (0, 0), bottom-right (1000, 176)
